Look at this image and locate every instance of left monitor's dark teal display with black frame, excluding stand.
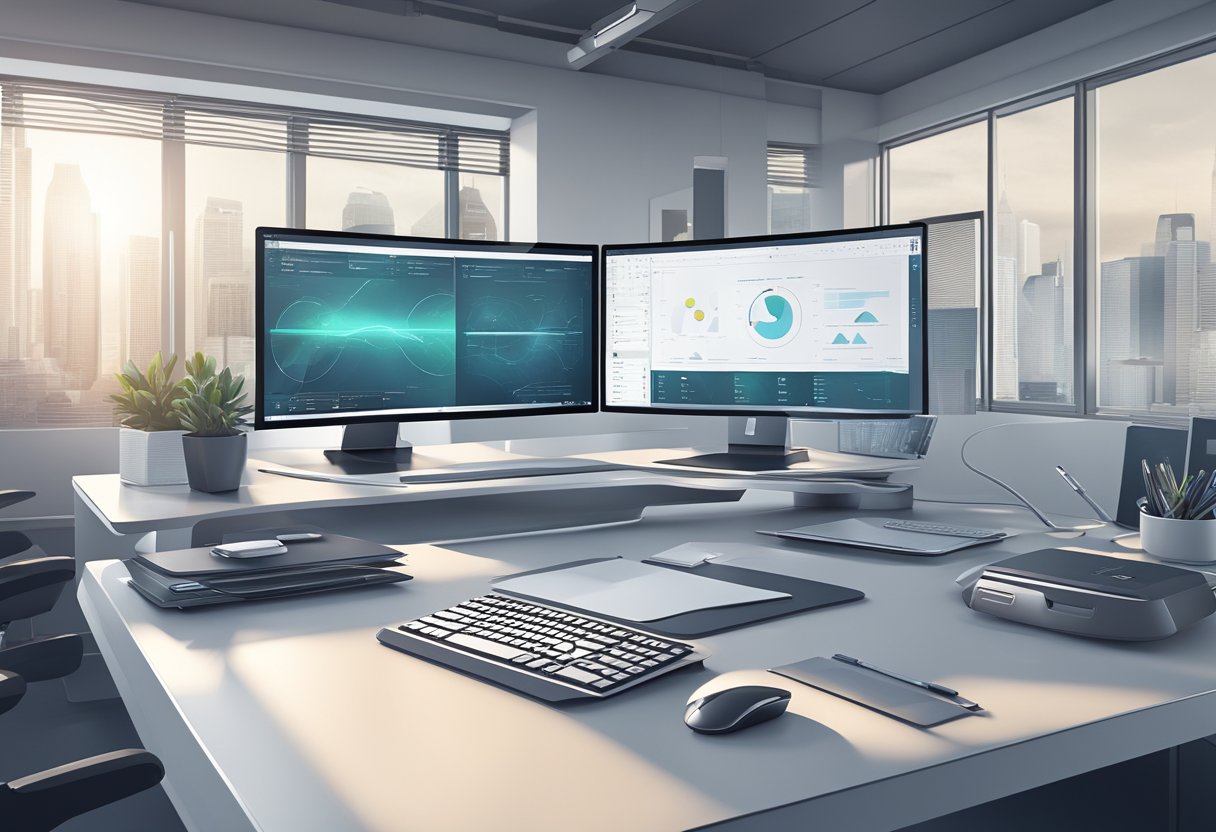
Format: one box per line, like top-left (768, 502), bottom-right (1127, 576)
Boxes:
top-left (255, 229), bottom-right (597, 428)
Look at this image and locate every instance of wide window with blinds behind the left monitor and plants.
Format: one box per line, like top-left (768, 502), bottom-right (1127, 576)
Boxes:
top-left (0, 79), bottom-right (510, 428)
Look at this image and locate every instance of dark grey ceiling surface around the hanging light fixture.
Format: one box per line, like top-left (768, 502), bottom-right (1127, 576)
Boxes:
top-left (118, 0), bottom-right (1109, 94)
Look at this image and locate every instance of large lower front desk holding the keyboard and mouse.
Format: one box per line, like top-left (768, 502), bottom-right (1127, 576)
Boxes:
top-left (79, 493), bottom-right (1216, 832)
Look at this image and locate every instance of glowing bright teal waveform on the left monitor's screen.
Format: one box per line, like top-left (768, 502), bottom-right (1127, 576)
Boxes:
top-left (270, 280), bottom-right (456, 384)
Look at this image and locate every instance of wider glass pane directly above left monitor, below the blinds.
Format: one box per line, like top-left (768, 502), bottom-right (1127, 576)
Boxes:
top-left (304, 156), bottom-right (444, 237)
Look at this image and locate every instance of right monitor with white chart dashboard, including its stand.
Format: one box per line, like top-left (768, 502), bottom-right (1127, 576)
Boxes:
top-left (601, 223), bottom-right (928, 471)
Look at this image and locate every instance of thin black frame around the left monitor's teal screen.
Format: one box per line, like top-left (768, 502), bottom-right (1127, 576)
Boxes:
top-left (253, 226), bottom-right (602, 431)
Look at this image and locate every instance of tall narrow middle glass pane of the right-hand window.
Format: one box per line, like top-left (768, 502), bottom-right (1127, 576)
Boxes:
top-left (992, 97), bottom-right (1074, 404)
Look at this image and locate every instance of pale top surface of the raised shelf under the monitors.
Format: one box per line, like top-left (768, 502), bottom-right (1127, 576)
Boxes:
top-left (72, 443), bottom-right (908, 534)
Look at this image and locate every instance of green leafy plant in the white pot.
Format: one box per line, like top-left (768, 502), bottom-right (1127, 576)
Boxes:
top-left (109, 353), bottom-right (186, 485)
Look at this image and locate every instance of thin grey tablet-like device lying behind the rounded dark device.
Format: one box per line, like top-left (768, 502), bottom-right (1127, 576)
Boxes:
top-left (756, 517), bottom-right (1008, 555)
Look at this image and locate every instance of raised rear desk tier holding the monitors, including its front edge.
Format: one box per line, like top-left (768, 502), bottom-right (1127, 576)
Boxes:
top-left (72, 443), bottom-right (906, 562)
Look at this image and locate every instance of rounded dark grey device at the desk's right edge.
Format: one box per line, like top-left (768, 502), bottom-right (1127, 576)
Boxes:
top-left (961, 549), bottom-right (1216, 641)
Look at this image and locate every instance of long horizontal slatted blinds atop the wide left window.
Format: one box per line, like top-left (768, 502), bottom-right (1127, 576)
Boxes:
top-left (0, 79), bottom-right (511, 175)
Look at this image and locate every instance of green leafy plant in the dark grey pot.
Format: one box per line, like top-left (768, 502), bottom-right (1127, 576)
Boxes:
top-left (174, 353), bottom-right (253, 494)
